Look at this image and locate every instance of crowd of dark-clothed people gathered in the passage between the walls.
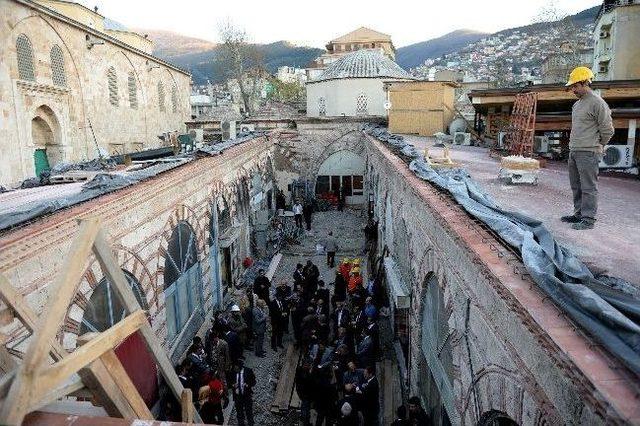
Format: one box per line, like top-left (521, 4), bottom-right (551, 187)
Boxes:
top-left (168, 225), bottom-right (430, 426)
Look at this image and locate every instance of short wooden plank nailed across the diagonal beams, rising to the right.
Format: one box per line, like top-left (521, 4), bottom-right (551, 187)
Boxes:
top-left (38, 310), bottom-right (147, 389)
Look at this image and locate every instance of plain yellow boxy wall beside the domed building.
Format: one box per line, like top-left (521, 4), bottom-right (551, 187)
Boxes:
top-left (389, 81), bottom-right (455, 136)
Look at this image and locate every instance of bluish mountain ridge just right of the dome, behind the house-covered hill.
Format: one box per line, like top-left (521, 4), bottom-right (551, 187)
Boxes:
top-left (396, 30), bottom-right (489, 69)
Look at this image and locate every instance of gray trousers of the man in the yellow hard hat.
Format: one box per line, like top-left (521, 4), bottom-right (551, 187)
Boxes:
top-left (569, 151), bottom-right (600, 221)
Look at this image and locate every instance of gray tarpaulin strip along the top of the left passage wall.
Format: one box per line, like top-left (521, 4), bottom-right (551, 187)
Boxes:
top-left (0, 133), bottom-right (261, 231)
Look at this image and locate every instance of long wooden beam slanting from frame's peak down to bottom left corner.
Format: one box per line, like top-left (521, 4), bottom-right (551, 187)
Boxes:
top-left (0, 218), bottom-right (100, 425)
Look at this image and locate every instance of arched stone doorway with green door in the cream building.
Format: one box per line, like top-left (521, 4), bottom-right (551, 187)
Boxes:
top-left (31, 105), bottom-right (63, 176)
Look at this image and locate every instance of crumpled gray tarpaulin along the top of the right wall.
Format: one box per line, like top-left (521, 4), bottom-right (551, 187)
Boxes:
top-left (364, 126), bottom-right (640, 375)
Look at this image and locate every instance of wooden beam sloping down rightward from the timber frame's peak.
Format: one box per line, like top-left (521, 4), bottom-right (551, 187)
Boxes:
top-left (93, 231), bottom-right (201, 421)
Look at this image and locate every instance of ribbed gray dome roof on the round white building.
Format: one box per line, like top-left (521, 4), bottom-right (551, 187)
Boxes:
top-left (316, 49), bottom-right (415, 83)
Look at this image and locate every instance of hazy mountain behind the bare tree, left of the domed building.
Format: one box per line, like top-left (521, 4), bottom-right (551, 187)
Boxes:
top-left (142, 29), bottom-right (324, 84)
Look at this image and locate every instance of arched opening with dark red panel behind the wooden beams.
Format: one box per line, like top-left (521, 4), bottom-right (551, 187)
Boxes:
top-left (79, 270), bottom-right (158, 407)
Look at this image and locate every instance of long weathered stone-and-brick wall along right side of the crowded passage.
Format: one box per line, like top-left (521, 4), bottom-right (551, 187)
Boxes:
top-left (364, 134), bottom-right (621, 425)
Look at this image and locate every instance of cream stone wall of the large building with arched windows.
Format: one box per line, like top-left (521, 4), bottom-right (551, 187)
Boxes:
top-left (0, 0), bottom-right (191, 185)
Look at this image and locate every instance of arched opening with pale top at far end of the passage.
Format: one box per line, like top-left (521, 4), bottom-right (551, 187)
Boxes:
top-left (316, 150), bottom-right (365, 204)
